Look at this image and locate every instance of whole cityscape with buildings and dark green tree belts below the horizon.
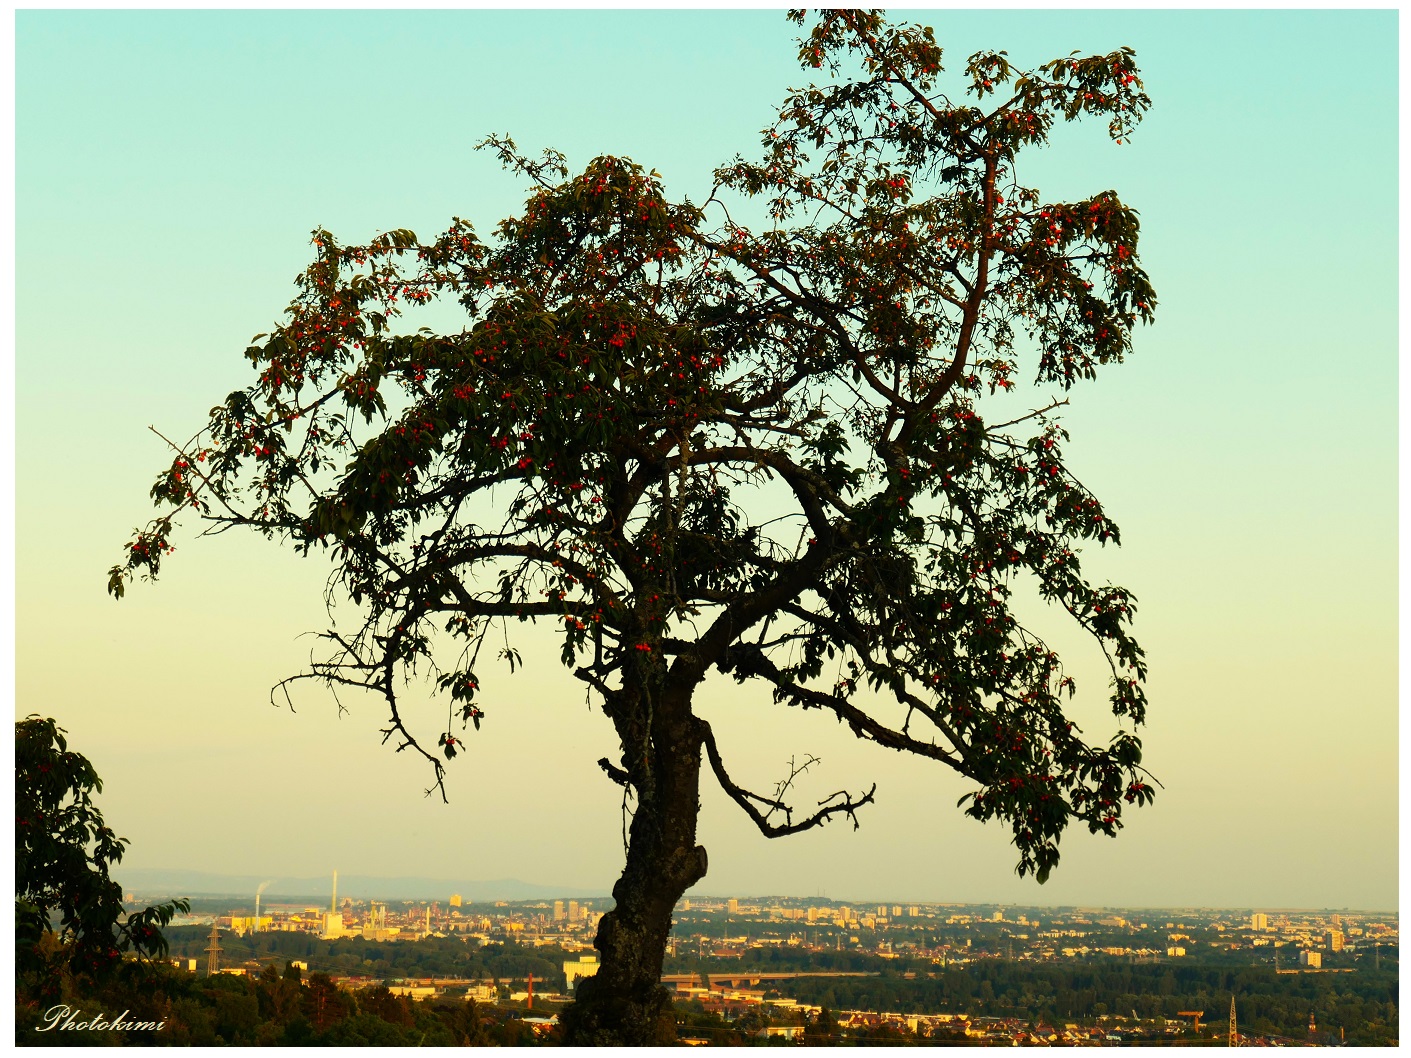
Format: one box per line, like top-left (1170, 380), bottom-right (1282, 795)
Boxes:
top-left (143, 897), bottom-right (1400, 1045)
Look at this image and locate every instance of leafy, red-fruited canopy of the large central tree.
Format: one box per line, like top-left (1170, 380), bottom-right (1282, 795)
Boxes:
top-left (109, 10), bottom-right (1156, 1049)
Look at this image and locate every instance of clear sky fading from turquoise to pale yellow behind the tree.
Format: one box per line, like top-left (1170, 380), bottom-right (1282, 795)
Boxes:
top-left (16, 10), bottom-right (1398, 910)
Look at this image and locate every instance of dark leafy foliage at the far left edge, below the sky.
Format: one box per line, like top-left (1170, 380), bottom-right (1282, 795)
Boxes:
top-left (14, 715), bottom-right (188, 995)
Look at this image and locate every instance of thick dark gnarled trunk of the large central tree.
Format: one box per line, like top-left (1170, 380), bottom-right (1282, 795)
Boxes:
top-left (563, 682), bottom-right (706, 1047)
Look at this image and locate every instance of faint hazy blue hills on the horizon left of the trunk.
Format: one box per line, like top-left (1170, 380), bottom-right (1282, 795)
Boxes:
top-left (113, 866), bottom-right (608, 903)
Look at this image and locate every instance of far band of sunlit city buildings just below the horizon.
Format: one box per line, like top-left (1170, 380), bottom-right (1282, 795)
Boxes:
top-left (182, 879), bottom-right (1398, 972)
